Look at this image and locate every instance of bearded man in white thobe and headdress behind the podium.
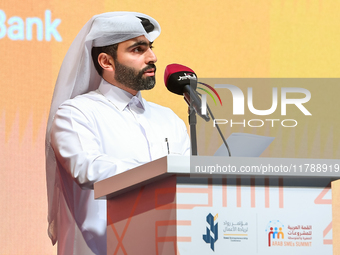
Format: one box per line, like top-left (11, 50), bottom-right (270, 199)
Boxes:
top-left (46, 12), bottom-right (189, 255)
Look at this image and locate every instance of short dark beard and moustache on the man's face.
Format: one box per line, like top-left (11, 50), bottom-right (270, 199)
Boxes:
top-left (115, 60), bottom-right (156, 91)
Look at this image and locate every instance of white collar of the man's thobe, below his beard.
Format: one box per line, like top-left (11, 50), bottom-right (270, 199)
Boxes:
top-left (98, 79), bottom-right (145, 111)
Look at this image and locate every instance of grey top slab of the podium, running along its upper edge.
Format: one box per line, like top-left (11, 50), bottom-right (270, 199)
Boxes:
top-left (94, 155), bottom-right (340, 199)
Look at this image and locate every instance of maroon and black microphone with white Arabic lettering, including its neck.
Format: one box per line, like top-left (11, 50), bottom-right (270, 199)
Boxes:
top-left (164, 64), bottom-right (210, 121)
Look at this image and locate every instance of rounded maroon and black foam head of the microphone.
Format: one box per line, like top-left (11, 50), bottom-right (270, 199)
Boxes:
top-left (164, 64), bottom-right (197, 95)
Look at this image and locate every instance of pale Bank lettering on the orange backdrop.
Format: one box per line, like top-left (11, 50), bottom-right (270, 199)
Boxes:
top-left (0, 10), bottom-right (63, 42)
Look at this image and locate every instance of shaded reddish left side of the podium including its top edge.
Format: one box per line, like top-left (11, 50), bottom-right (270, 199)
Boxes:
top-left (94, 156), bottom-right (190, 255)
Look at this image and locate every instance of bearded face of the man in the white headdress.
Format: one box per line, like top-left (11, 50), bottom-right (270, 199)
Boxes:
top-left (114, 36), bottom-right (157, 91)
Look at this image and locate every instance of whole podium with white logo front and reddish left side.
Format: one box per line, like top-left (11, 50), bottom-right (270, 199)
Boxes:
top-left (94, 155), bottom-right (340, 255)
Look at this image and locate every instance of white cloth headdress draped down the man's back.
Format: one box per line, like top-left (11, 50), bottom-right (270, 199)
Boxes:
top-left (45, 12), bottom-right (161, 244)
